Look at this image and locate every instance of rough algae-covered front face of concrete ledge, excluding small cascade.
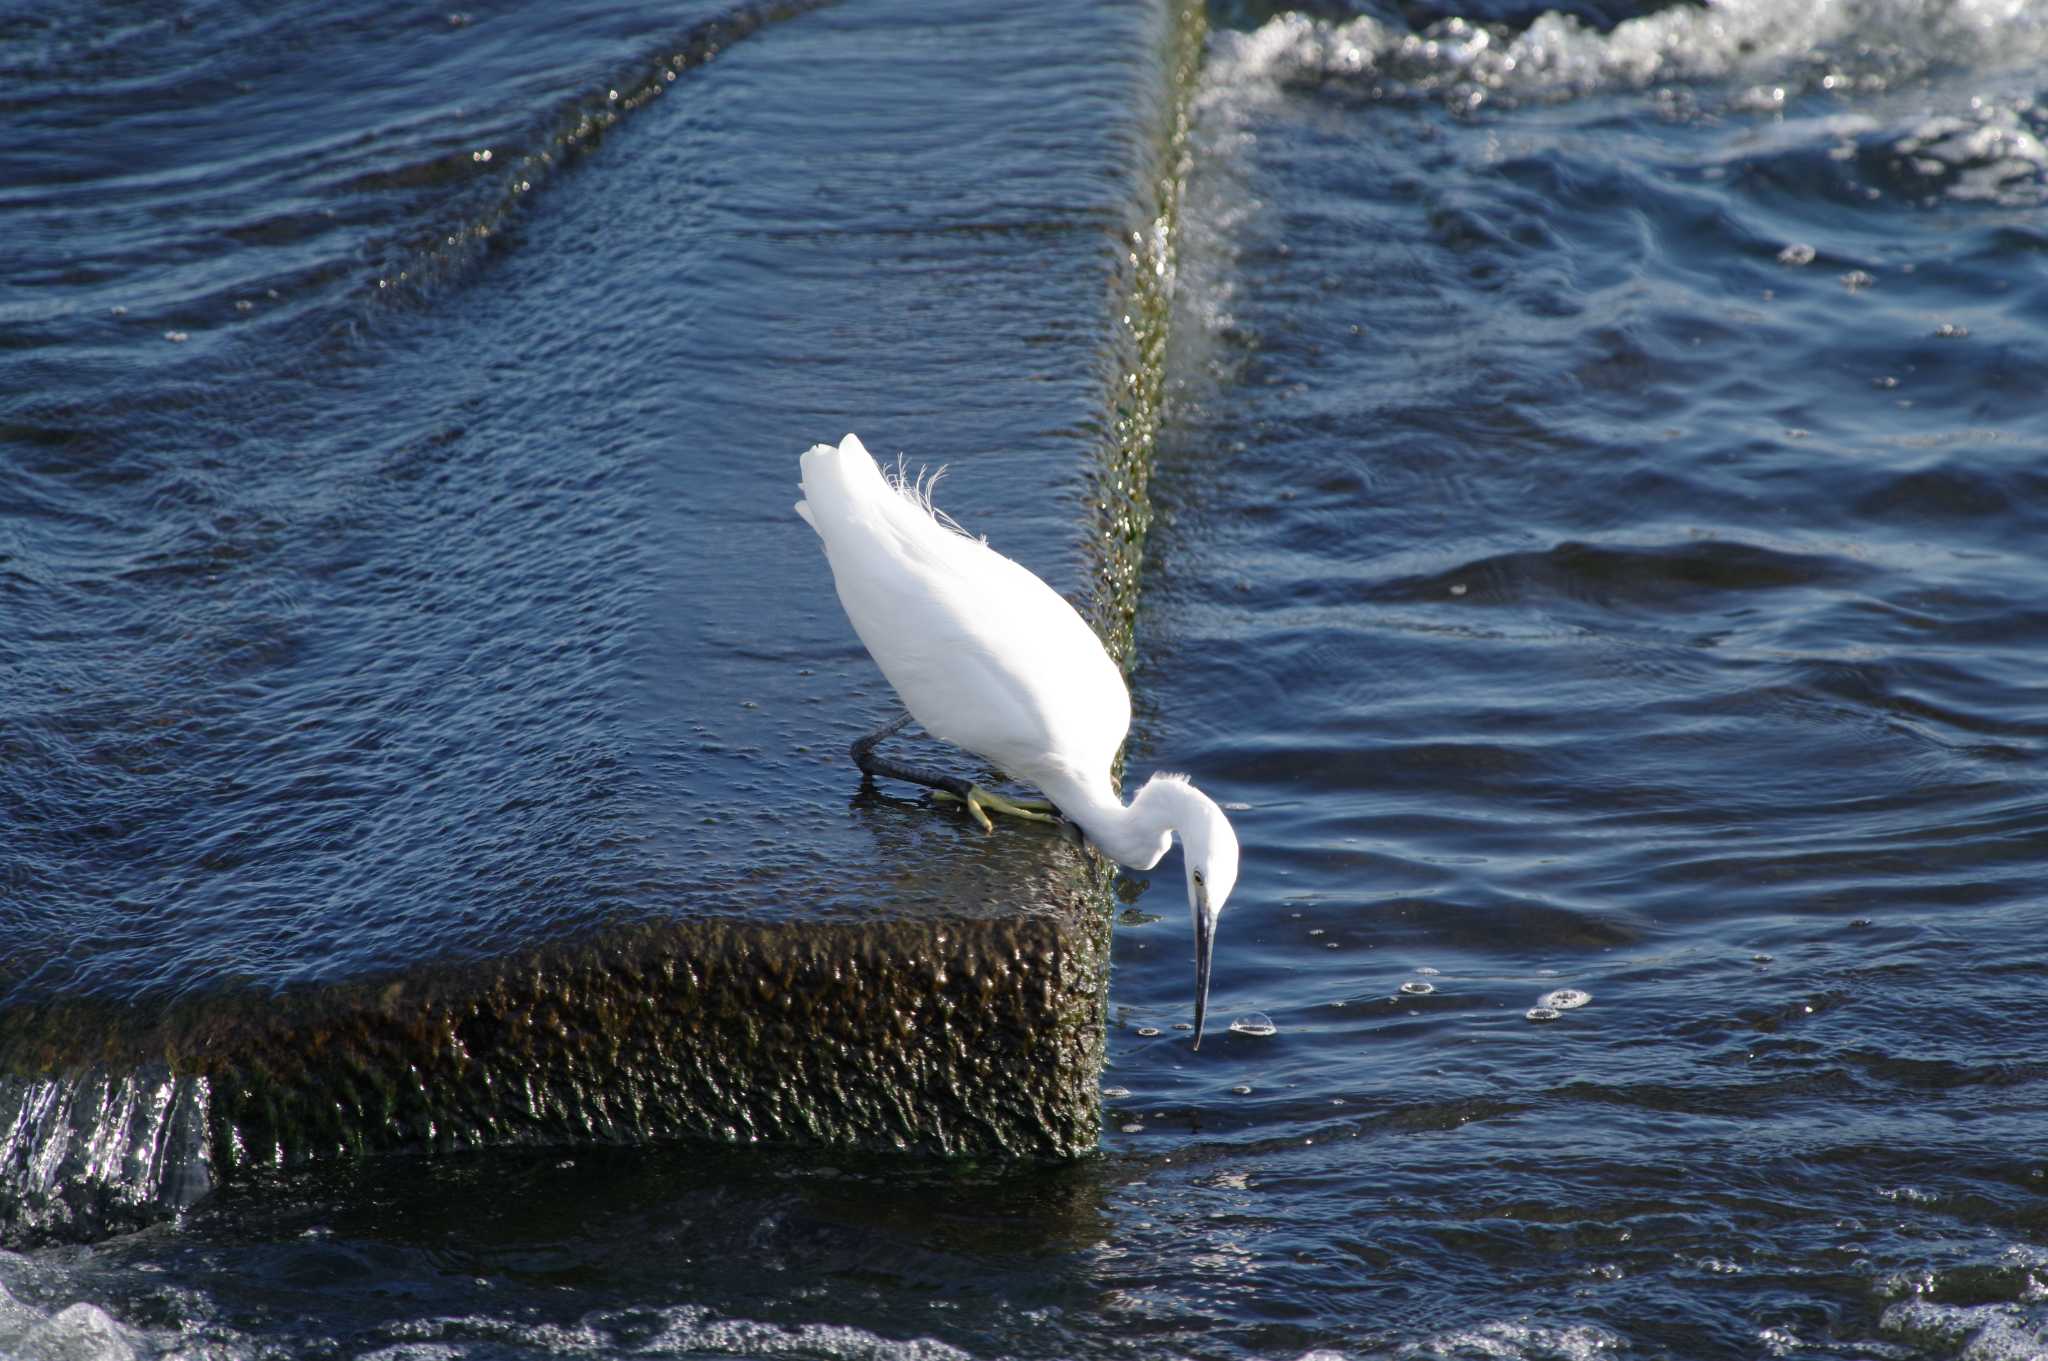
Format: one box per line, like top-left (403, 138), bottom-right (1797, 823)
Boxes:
top-left (190, 913), bottom-right (1106, 1169)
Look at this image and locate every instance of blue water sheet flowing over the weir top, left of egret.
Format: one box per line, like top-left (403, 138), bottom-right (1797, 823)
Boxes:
top-left (0, 4), bottom-right (1138, 999)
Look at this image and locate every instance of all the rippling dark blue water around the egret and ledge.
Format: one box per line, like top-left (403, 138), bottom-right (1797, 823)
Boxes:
top-left (0, 0), bottom-right (2048, 1359)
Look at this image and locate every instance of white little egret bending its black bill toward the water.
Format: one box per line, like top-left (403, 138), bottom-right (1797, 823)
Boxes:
top-left (797, 436), bottom-right (1237, 1048)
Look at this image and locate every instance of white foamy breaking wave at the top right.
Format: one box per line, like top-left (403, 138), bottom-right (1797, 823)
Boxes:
top-left (1202, 0), bottom-right (2048, 207)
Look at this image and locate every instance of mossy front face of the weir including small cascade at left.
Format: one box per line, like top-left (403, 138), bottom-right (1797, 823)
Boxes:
top-left (0, 880), bottom-right (1110, 1240)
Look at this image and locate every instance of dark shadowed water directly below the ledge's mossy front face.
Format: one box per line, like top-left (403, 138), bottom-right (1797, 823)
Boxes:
top-left (31, 1148), bottom-right (1114, 1357)
